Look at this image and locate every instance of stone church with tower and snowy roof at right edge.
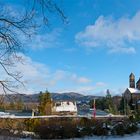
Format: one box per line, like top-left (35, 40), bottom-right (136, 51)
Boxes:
top-left (124, 73), bottom-right (140, 109)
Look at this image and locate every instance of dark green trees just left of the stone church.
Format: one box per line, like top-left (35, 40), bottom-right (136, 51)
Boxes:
top-left (89, 90), bottom-right (139, 115)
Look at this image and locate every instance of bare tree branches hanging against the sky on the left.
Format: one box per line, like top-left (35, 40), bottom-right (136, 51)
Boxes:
top-left (0, 0), bottom-right (67, 102)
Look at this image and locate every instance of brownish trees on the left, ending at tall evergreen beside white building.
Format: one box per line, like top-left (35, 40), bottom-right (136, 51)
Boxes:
top-left (0, 90), bottom-right (53, 112)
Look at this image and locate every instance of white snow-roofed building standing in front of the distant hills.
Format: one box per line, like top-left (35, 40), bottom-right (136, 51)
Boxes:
top-left (52, 101), bottom-right (77, 115)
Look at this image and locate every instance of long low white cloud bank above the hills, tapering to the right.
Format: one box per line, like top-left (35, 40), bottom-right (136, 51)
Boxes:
top-left (0, 54), bottom-right (109, 94)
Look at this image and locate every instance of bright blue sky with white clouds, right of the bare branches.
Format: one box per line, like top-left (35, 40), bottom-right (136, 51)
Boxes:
top-left (3, 0), bottom-right (140, 96)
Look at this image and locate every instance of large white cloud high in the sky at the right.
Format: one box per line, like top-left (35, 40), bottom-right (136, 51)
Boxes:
top-left (75, 12), bottom-right (140, 53)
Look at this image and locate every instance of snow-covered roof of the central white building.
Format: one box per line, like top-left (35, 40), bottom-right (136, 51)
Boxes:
top-left (54, 101), bottom-right (77, 112)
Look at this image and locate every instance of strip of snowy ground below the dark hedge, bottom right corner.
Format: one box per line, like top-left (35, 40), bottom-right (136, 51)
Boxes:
top-left (74, 134), bottom-right (140, 140)
